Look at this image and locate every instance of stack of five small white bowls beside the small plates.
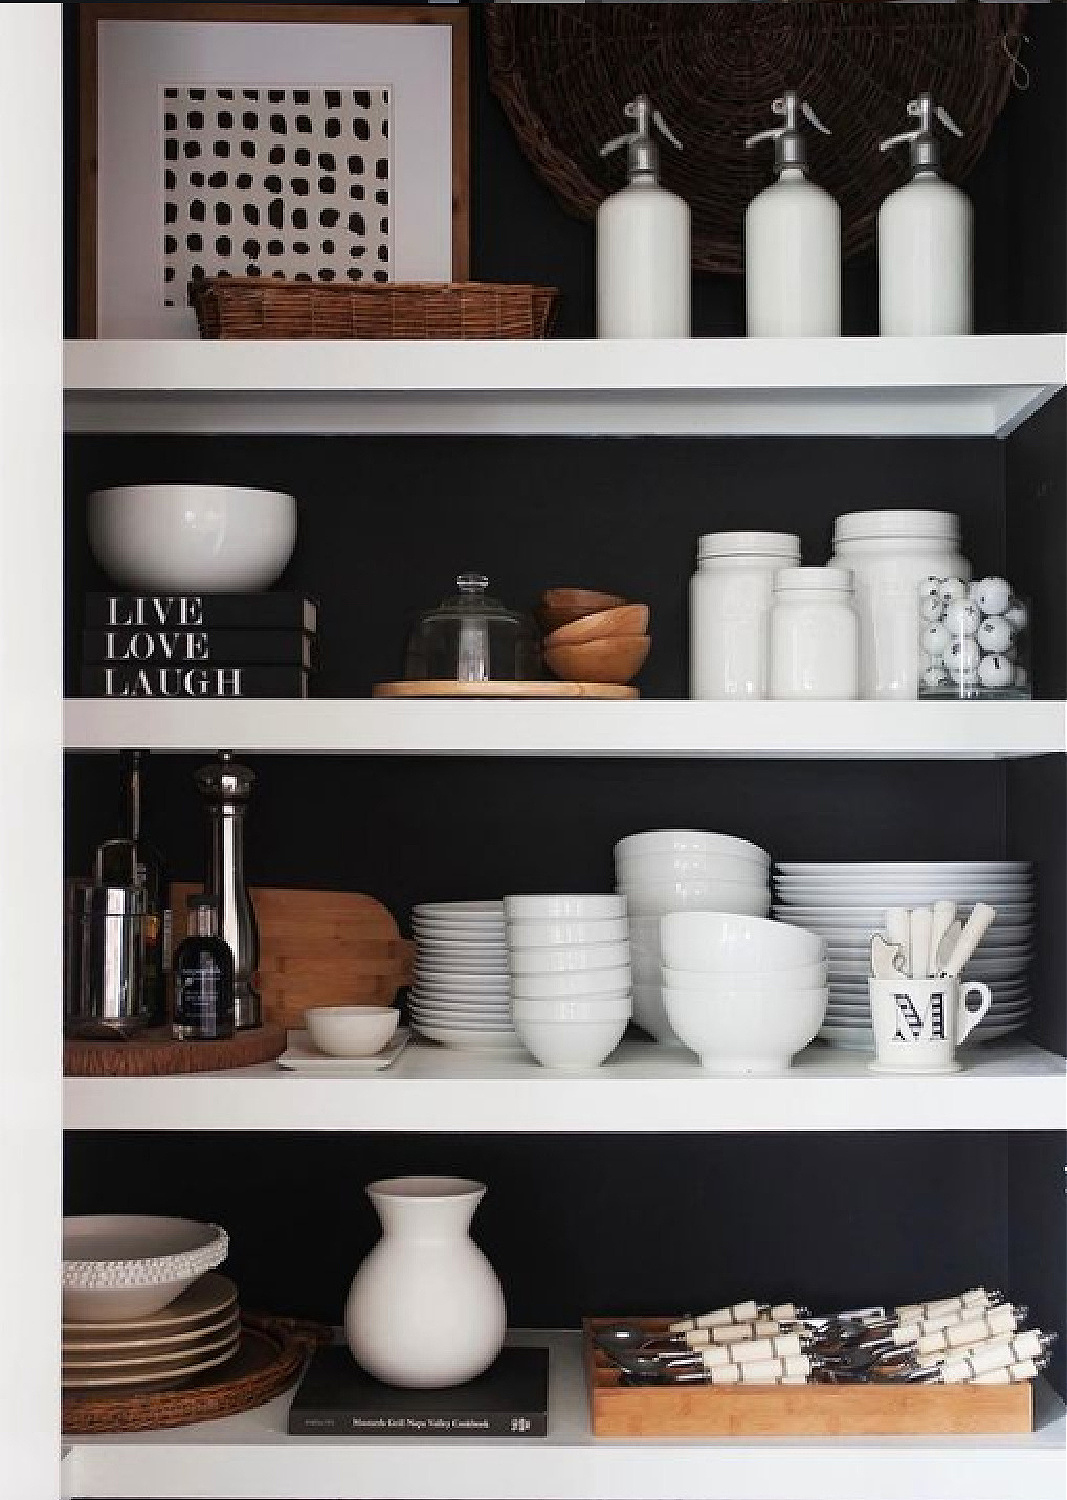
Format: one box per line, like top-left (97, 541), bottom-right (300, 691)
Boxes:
top-left (504, 896), bottom-right (633, 1071)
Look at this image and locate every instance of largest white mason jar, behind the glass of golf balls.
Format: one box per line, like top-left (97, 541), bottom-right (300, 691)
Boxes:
top-left (833, 510), bottom-right (971, 699)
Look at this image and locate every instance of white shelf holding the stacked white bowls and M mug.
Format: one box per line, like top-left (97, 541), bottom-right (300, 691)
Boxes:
top-left (63, 1035), bottom-right (1067, 1134)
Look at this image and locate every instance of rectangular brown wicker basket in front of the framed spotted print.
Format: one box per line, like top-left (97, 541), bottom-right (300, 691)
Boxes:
top-left (189, 276), bottom-right (558, 339)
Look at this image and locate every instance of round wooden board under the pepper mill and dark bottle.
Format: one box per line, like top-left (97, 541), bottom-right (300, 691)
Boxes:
top-left (63, 1025), bottom-right (287, 1079)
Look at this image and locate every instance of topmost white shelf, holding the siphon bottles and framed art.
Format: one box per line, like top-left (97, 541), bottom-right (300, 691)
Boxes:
top-left (65, 335), bottom-right (1067, 438)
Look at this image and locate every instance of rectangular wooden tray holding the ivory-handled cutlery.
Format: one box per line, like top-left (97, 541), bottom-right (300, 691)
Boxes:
top-left (582, 1319), bottom-right (1034, 1437)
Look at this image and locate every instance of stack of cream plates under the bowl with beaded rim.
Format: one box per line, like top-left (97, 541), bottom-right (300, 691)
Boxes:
top-left (63, 1272), bottom-right (240, 1391)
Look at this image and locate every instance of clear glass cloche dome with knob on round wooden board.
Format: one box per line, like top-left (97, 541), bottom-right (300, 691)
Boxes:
top-left (404, 573), bottom-right (542, 683)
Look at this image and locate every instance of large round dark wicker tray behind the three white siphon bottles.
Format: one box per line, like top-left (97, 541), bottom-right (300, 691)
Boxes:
top-left (482, 0), bottom-right (1026, 272)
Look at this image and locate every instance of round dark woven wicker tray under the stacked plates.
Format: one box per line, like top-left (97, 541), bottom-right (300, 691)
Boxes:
top-left (63, 1313), bottom-right (332, 1436)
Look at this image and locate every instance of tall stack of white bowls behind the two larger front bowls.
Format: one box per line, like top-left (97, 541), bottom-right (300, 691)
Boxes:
top-left (615, 828), bottom-right (770, 1046)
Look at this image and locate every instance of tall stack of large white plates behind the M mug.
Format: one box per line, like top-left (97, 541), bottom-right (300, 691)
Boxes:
top-left (774, 860), bottom-right (1034, 1049)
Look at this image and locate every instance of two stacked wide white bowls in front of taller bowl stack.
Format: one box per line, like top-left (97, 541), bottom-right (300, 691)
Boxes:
top-left (662, 912), bottom-right (827, 1076)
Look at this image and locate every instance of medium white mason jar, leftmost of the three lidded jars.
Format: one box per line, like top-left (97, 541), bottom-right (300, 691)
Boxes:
top-left (689, 531), bottom-right (800, 699)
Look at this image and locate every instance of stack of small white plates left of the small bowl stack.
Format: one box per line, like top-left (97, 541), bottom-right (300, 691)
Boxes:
top-left (410, 902), bottom-right (522, 1052)
